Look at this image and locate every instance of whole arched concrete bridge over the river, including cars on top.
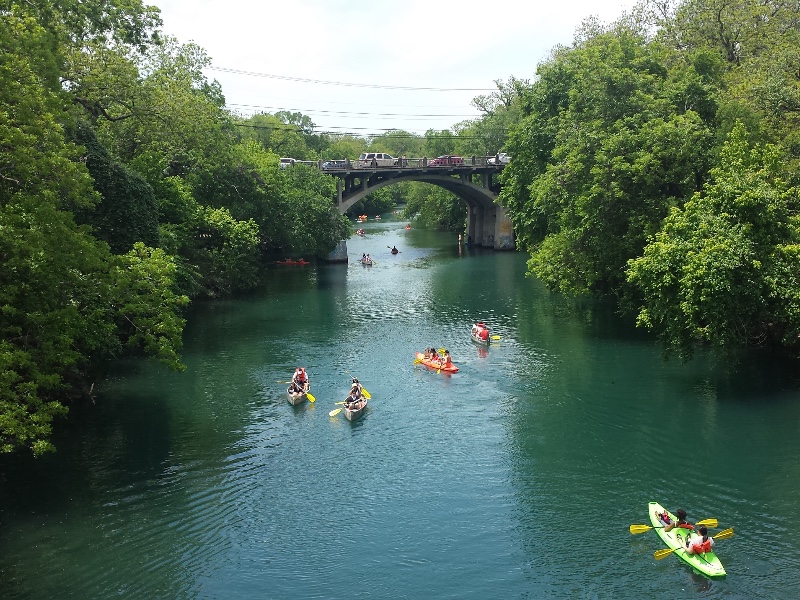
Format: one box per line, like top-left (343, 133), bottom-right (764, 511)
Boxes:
top-left (319, 156), bottom-right (514, 250)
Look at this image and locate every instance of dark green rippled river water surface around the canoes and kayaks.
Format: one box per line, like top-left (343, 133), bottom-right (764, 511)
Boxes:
top-left (0, 219), bottom-right (800, 600)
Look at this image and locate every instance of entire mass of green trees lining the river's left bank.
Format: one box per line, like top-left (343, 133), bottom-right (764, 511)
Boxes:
top-left (0, 0), bottom-right (350, 454)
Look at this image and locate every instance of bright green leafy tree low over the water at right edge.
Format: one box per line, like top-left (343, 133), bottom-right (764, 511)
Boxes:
top-left (627, 124), bottom-right (800, 357)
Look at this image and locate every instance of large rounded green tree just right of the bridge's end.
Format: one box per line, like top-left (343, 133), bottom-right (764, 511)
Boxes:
top-left (500, 26), bottom-right (712, 294)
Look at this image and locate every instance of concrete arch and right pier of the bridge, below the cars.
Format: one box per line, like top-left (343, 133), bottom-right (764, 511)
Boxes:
top-left (337, 167), bottom-right (515, 250)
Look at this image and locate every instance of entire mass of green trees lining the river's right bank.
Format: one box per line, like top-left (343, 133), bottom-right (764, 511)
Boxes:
top-left (501, 0), bottom-right (800, 357)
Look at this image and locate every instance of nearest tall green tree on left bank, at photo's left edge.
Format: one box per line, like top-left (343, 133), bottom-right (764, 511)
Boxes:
top-left (0, 11), bottom-right (188, 454)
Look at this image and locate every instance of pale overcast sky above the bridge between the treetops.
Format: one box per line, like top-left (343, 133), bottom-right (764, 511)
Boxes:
top-left (153, 0), bottom-right (634, 136)
